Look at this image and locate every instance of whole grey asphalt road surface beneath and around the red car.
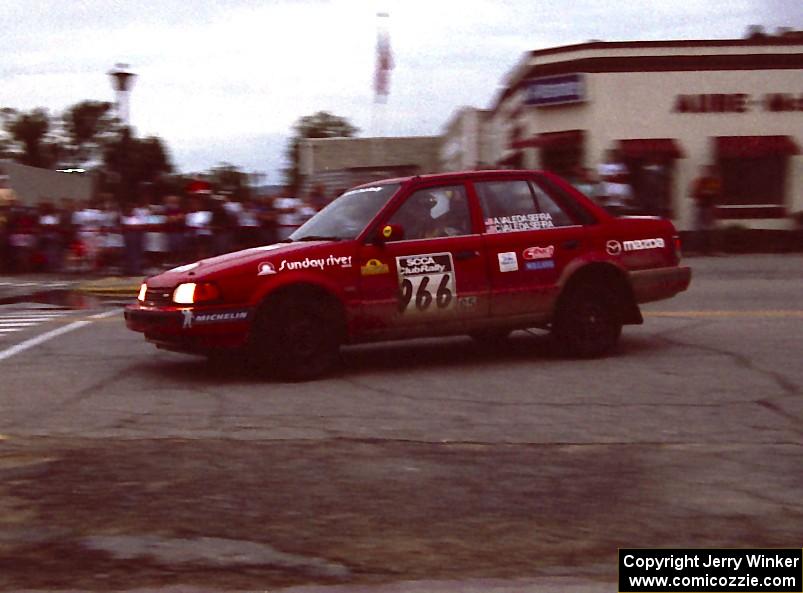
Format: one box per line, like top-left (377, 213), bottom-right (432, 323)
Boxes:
top-left (0, 255), bottom-right (803, 592)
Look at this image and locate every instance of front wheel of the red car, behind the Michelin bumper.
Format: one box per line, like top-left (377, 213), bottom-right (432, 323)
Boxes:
top-left (252, 298), bottom-right (342, 381)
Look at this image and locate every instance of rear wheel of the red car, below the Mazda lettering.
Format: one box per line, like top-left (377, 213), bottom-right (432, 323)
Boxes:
top-left (552, 286), bottom-right (622, 358)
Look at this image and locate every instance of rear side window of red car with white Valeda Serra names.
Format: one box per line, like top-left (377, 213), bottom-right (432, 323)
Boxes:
top-left (474, 180), bottom-right (574, 233)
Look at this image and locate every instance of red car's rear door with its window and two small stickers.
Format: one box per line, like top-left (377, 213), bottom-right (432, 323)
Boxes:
top-left (473, 176), bottom-right (587, 321)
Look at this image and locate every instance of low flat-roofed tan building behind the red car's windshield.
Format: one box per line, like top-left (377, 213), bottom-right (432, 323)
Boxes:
top-left (299, 136), bottom-right (441, 196)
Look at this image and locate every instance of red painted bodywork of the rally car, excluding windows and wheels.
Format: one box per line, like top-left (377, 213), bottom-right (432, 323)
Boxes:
top-left (125, 171), bottom-right (691, 352)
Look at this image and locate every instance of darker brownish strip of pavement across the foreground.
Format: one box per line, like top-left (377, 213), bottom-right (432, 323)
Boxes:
top-left (0, 439), bottom-right (803, 591)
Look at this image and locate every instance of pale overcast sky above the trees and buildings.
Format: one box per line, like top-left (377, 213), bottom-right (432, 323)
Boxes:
top-left (0, 0), bottom-right (803, 183)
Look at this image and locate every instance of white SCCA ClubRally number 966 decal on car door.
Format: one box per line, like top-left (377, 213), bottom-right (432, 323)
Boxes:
top-left (396, 253), bottom-right (456, 313)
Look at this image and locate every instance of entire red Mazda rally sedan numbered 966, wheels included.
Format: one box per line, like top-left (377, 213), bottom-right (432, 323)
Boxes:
top-left (125, 171), bottom-right (691, 379)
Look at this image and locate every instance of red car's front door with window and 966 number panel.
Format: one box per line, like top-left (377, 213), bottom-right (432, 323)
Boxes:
top-left (358, 184), bottom-right (490, 335)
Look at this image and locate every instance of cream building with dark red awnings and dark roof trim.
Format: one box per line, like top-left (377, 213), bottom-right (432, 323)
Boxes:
top-left (450, 32), bottom-right (803, 229)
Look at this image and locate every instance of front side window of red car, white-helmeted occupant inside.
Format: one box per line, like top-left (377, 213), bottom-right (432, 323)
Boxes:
top-left (388, 185), bottom-right (471, 240)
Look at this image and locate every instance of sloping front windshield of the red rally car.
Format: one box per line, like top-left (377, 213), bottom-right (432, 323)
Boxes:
top-left (290, 183), bottom-right (399, 241)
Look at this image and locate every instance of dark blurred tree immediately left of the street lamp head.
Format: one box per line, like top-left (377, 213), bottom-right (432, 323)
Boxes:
top-left (61, 101), bottom-right (119, 165)
